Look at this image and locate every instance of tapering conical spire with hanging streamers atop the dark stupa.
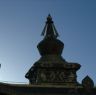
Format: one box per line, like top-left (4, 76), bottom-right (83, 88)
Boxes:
top-left (41, 14), bottom-right (59, 38)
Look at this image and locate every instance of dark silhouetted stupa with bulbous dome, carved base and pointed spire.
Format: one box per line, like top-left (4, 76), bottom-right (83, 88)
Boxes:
top-left (25, 15), bottom-right (81, 86)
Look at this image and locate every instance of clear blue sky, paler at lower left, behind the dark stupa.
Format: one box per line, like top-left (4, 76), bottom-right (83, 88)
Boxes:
top-left (0, 0), bottom-right (96, 84)
